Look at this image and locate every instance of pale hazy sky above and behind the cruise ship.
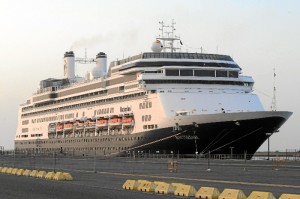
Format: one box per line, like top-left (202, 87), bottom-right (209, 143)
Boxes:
top-left (0, 0), bottom-right (300, 151)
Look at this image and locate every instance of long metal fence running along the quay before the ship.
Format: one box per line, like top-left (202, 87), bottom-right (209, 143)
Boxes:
top-left (0, 150), bottom-right (300, 173)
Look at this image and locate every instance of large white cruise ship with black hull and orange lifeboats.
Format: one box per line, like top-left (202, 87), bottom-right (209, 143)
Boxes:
top-left (15, 23), bottom-right (292, 156)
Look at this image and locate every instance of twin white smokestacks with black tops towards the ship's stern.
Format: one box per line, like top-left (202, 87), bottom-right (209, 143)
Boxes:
top-left (64, 51), bottom-right (107, 80)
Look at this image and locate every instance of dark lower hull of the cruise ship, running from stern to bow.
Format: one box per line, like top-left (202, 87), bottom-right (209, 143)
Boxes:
top-left (15, 112), bottom-right (291, 157)
